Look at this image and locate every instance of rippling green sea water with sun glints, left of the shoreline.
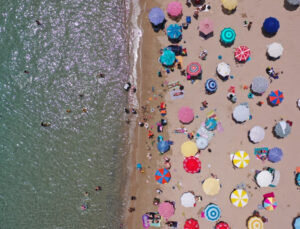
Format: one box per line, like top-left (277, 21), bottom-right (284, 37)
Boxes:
top-left (0, 0), bottom-right (129, 229)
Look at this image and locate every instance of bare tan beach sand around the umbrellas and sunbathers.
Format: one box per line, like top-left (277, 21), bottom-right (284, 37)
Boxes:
top-left (124, 0), bottom-right (300, 229)
